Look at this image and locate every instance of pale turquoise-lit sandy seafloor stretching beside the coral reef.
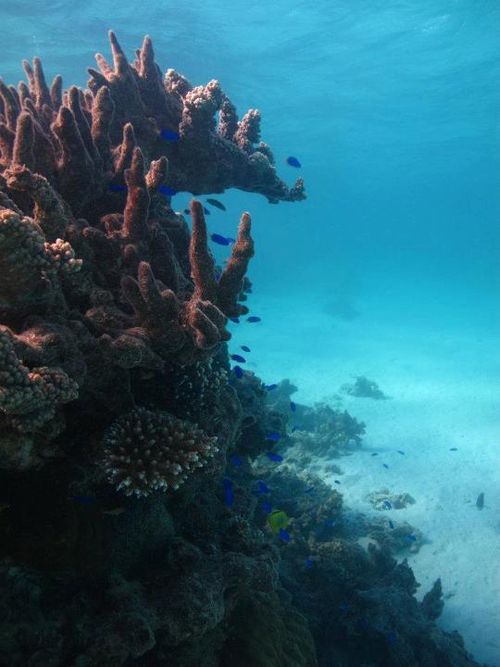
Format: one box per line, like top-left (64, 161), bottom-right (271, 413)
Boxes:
top-left (230, 291), bottom-right (500, 667)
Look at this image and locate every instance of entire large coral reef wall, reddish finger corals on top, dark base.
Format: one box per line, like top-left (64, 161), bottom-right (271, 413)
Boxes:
top-left (0, 33), bottom-right (475, 667)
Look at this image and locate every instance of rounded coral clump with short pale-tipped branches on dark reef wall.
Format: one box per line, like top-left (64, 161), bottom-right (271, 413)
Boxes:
top-left (103, 408), bottom-right (218, 497)
